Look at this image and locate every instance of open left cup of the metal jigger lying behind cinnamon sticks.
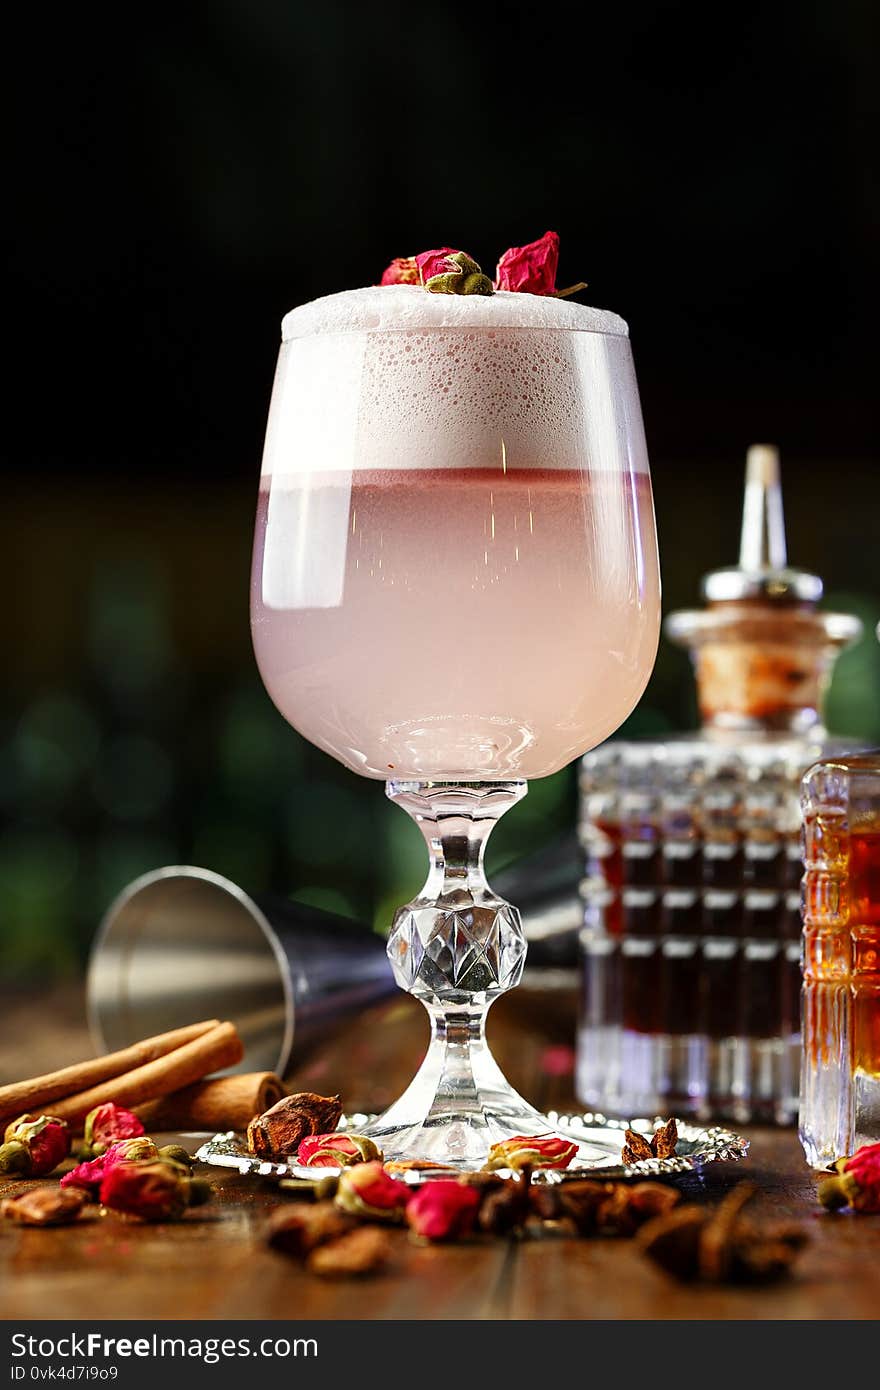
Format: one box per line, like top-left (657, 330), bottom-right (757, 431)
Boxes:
top-left (88, 865), bottom-right (396, 1076)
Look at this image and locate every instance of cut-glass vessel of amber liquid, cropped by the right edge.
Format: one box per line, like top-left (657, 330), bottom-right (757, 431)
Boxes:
top-left (801, 752), bottom-right (880, 1168)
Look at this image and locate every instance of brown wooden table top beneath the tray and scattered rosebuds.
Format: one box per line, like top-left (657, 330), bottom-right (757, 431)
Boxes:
top-left (0, 988), bottom-right (880, 1319)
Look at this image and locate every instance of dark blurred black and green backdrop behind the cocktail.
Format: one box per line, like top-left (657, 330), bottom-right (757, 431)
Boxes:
top-left (0, 0), bottom-right (880, 976)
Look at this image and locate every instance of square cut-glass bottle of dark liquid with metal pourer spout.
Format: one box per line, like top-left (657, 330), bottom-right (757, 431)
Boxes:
top-left (577, 445), bottom-right (862, 1123)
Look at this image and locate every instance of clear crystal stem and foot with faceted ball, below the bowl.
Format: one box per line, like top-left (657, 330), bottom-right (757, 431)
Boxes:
top-left (358, 781), bottom-right (569, 1168)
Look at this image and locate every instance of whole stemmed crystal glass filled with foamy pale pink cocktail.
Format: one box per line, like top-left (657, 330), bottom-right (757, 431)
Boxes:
top-left (252, 285), bottom-right (659, 1168)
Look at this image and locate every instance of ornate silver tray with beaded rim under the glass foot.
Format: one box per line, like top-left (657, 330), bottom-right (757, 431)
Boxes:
top-left (196, 1111), bottom-right (749, 1183)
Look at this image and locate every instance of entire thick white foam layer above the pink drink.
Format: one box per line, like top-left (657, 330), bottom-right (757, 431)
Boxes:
top-left (263, 285), bottom-right (648, 475)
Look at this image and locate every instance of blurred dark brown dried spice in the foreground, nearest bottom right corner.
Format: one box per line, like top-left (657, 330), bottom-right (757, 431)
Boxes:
top-left (638, 1183), bottom-right (808, 1283)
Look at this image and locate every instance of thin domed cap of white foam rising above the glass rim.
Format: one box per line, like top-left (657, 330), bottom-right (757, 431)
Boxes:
top-left (281, 285), bottom-right (628, 341)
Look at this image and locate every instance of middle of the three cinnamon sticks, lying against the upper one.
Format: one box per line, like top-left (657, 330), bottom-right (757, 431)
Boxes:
top-left (51, 1023), bottom-right (245, 1130)
